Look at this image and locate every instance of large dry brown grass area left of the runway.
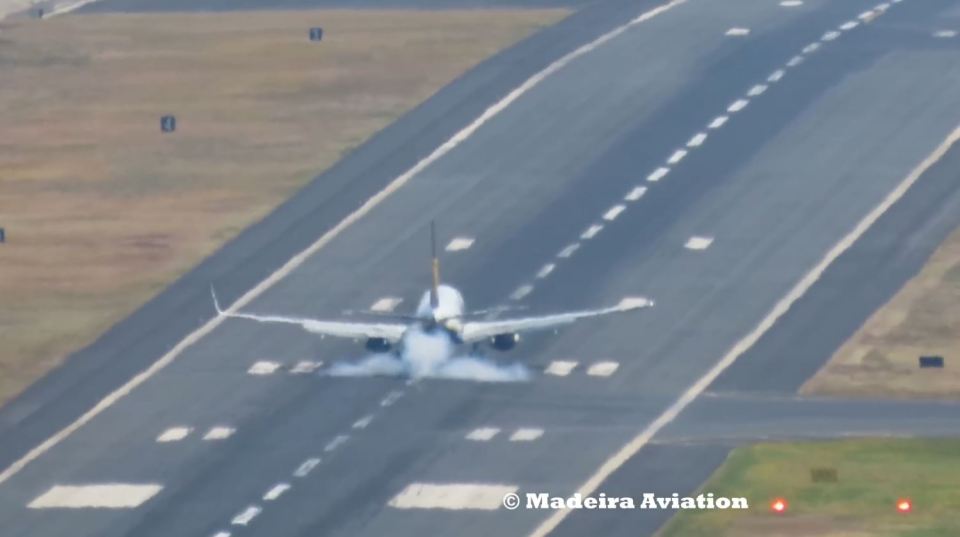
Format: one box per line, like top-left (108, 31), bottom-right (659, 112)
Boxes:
top-left (0, 10), bottom-right (566, 401)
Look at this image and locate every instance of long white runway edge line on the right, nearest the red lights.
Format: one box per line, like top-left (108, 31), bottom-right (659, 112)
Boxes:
top-left (530, 125), bottom-right (960, 537)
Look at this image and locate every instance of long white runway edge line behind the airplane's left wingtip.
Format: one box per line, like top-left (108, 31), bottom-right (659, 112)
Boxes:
top-left (0, 0), bottom-right (687, 490)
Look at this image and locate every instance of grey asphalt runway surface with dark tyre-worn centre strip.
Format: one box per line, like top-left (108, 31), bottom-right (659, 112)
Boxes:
top-left (0, 0), bottom-right (960, 537)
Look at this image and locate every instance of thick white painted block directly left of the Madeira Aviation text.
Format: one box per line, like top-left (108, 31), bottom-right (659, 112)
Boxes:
top-left (387, 483), bottom-right (517, 511)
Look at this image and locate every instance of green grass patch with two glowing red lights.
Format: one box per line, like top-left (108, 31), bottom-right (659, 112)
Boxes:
top-left (659, 439), bottom-right (960, 537)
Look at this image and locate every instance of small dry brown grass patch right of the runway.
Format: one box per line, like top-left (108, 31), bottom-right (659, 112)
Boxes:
top-left (801, 224), bottom-right (960, 398)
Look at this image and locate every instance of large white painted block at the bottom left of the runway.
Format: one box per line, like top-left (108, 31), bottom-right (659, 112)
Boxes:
top-left (27, 483), bottom-right (163, 509)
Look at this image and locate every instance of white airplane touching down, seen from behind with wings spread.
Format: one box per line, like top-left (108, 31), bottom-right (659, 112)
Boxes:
top-left (210, 222), bottom-right (654, 356)
